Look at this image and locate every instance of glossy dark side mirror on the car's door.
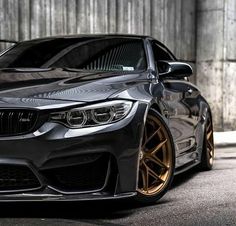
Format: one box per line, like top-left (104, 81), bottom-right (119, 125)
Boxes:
top-left (157, 61), bottom-right (193, 78)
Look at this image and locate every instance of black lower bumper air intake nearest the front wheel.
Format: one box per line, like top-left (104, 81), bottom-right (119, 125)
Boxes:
top-left (41, 154), bottom-right (110, 192)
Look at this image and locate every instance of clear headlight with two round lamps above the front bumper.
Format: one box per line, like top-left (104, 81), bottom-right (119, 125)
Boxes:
top-left (50, 100), bottom-right (132, 128)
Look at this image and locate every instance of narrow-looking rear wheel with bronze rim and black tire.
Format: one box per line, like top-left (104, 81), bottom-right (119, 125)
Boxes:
top-left (199, 115), bottom-right (214, 171)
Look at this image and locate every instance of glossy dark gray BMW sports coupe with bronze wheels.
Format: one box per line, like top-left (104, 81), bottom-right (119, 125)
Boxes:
top-left (0, 35), bottom-right (214, 203)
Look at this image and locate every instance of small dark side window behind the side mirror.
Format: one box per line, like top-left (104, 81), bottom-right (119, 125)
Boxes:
top-left (152, 42), bottom-right (174, 72)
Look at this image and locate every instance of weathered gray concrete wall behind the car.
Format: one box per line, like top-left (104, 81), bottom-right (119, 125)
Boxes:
top-left (0, 0), bottom-right (236, 130)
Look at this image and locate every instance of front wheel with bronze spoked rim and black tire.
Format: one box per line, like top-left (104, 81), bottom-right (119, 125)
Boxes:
top-left (135, 109), bottom-right (175, 204)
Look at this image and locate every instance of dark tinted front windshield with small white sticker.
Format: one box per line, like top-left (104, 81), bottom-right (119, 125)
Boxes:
top-left (0, 37), bottom-right (147, 71)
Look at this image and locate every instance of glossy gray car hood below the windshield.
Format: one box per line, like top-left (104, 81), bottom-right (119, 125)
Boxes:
top-left (0, 69), bottom-right (146, 106)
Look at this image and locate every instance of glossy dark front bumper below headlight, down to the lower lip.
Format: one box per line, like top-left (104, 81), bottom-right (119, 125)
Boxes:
top-left (0, 102), bottom-right (146, 201)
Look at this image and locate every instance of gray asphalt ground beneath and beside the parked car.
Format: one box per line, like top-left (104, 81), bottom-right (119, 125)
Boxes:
top-left (0, 147), bottom-right (236, 226)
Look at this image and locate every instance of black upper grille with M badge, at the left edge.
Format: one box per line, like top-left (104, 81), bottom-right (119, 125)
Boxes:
top-left (0, 109), bottom-right (38, 136)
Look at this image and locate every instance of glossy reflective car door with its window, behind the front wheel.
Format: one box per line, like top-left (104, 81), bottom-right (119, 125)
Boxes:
top-left (152, 42), bottom-right (199, 167)
